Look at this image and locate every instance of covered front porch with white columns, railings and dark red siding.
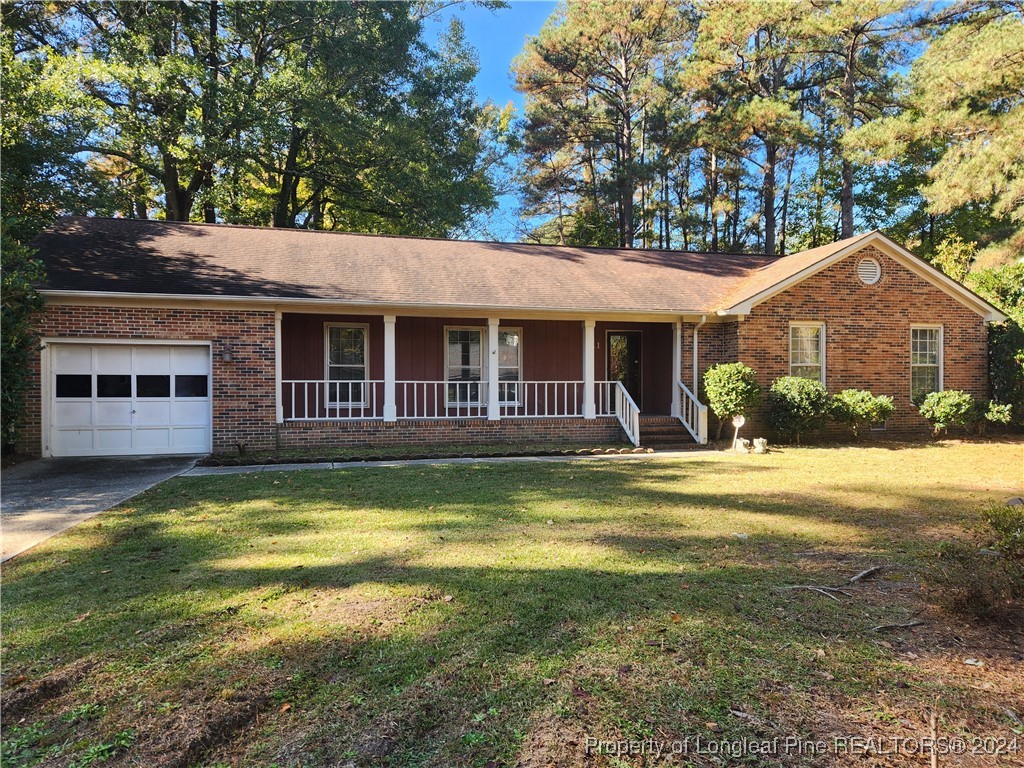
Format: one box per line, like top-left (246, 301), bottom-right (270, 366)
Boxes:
top-left (275, 312), bottom-right (708, 445)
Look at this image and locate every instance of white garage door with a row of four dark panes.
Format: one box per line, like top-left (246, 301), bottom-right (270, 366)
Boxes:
top-left (49, 343), bottom-right (211, 456)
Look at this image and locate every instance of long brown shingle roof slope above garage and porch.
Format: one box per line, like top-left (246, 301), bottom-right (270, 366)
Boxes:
top-left (32, 217), bottom-right (772, 312)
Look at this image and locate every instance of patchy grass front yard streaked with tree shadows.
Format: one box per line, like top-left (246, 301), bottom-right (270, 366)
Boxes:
top-left (2, 440), bottom-right (1024, 768)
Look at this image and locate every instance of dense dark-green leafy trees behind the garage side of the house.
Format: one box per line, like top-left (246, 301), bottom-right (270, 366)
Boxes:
top-left (3, 0), bottom-right (508, 236)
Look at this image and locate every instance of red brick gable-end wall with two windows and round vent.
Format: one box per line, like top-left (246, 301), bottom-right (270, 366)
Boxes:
top-left (737, 248), bottom-right (988, 435)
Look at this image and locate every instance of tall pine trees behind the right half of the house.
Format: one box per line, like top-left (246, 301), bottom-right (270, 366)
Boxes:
top-left (514, 0), bottom-right (1024, 268)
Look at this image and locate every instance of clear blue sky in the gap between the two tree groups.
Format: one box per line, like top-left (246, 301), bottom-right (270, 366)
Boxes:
top-left (428, 0), bottom-right (556, 241)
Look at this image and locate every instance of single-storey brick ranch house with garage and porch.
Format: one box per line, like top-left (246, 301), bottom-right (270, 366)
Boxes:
top-left (18, 217), bottom-right (1004, 456)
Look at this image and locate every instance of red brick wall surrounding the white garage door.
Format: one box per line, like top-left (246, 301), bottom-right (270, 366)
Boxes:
top-left (17, 305), bottom-right (274, 455)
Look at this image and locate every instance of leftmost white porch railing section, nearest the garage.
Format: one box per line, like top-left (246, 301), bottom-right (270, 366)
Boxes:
top-left (281, 379), bottom-right (384, 421)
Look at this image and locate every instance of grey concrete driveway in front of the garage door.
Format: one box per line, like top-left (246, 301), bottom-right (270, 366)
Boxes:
top-left (0, 456), bottom-right (199, 561)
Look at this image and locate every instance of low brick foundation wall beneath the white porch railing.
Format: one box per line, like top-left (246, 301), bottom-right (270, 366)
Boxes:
top-left (281, 418), bottom-right (626, 447)
